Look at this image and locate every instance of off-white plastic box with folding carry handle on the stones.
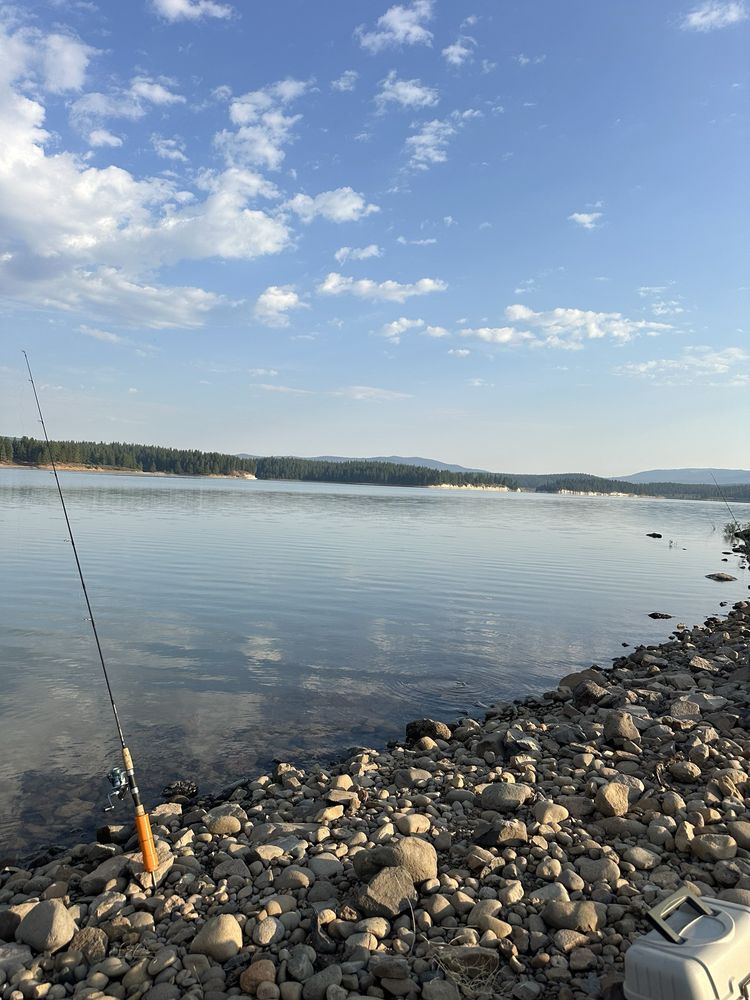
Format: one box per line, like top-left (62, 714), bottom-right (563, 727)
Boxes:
top-left (625, 886), bottom-right (750, 1000)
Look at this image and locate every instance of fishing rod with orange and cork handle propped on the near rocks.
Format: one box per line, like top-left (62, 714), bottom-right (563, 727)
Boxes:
top-left (23, 351), bottom-right (159, 886)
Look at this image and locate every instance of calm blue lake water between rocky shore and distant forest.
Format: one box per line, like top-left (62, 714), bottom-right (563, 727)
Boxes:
top-left (0, 470), bottom-right (750, 859)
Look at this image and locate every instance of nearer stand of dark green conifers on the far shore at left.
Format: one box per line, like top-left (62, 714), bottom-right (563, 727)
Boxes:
top-left (0, 437), bottom-right (255, 476)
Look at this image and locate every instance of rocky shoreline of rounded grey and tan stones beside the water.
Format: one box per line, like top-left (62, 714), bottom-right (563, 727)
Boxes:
top-left (0, 601), bottom-right (750, 1000)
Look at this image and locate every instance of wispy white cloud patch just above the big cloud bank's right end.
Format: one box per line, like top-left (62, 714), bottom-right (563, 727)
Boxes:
top-left (214, 78), bottom-right (309, 170)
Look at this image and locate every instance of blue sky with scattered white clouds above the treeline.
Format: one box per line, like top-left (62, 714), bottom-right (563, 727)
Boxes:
top-left (0, 0), bottom-right (750, 474)
